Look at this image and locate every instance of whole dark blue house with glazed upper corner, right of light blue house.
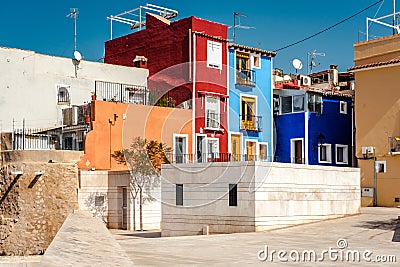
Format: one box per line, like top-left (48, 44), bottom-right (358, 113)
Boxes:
top-left (274, 88), bottom-right (353, 166)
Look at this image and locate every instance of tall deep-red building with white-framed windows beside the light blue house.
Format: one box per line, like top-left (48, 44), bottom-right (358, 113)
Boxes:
top-left (104, 13), bottom-right (229, 161)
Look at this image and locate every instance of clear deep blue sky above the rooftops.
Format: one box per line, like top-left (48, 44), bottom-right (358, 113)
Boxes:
top-left (0, 0), bottom-right (400, 73)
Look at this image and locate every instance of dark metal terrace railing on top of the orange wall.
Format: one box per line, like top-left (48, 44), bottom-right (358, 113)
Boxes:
top-left (94, 81), bottom-right (149, 105)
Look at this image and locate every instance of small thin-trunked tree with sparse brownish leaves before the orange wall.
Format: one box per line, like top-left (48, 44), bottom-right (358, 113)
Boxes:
top-left (112, 137), bottom-right (171, 231)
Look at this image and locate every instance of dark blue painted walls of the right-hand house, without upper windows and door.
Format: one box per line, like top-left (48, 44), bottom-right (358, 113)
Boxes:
top-left (275, 89), bottom-right (352, 166)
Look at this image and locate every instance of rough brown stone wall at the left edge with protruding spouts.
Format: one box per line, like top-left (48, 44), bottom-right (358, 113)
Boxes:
top-left (0, 151), bottom-right (81, 255)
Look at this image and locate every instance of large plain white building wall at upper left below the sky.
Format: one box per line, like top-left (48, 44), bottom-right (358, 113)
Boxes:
top-left (0, 47), bottom-right (149, 131)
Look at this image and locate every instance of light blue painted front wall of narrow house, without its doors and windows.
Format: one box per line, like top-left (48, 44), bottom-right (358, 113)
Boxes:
top-left (229, 47), bottom-right (273, 160)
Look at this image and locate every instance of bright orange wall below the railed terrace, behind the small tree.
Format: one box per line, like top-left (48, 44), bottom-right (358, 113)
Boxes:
top-left (78, 100), bottom-right (192, 170)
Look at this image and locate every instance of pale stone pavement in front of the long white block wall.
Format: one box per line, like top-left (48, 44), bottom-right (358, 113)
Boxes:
top-left (113, 208), bottom-right (400, 266)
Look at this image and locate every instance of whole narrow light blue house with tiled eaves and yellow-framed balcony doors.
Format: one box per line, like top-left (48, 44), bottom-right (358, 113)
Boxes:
top-left (228, 44), bottom-right (276, 161)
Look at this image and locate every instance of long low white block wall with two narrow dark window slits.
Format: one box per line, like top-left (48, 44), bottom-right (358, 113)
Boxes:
top-left (161, 162), bottom-right (360, 236)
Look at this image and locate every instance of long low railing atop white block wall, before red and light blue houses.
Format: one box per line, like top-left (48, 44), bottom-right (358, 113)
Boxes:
top-left (166, 152), bottom-right (277, 164)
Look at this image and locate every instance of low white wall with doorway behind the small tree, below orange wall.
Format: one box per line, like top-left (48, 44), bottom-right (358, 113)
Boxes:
top-left (78, 171), bottom-right (161, 230)
